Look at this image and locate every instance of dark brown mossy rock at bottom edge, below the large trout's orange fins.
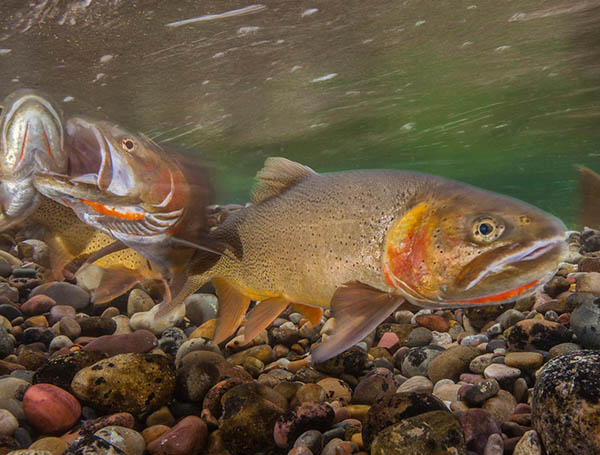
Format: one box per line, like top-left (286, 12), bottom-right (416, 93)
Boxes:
top-left (220, 382), bottom-right (287, 455)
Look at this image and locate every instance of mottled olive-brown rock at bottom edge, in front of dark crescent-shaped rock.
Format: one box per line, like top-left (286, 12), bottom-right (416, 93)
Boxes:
top-left (371, 411), bottom-right (467, 455)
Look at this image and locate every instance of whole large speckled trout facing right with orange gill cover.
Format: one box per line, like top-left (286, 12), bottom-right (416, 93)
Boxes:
top-left (167, 158), bottom-right (567, 362)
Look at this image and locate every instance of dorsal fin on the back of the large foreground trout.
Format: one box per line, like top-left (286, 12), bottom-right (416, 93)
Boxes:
top-left (252, 157), bottom-right (316, 204)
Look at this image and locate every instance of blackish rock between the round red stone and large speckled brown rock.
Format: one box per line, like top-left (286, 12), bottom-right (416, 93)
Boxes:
top-left (33, 349), bottom-right (106, 390)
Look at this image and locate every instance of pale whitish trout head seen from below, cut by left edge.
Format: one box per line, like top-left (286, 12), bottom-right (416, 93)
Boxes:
top-left (0, 89), bottom-right (67, 230)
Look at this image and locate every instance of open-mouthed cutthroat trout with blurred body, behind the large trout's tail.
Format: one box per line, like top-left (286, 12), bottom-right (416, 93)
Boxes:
top-left (34, 117), bottom-right (218, 278)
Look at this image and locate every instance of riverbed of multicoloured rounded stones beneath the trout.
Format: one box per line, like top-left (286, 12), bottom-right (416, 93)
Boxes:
top-left (0, 216), bottom-right (600, 455)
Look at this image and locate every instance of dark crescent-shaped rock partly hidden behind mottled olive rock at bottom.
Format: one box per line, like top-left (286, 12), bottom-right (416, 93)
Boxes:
top-left (362, 393), bottom-right (449, 448)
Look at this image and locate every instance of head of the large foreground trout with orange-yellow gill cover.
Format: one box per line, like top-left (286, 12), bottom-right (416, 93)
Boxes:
top-left (383, 181), bottom-right (567, 307)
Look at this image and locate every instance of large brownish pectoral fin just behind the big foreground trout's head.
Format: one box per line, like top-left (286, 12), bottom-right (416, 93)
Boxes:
top-left (311, 281), bottom-right (403, 363)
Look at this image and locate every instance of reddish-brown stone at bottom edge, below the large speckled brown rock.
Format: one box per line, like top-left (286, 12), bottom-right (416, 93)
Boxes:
top-left (147, 416), bottom-right (208, 455)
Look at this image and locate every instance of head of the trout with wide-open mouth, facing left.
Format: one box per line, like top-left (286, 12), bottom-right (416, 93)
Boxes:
top-left (35, 118), bottom-right (189, 244)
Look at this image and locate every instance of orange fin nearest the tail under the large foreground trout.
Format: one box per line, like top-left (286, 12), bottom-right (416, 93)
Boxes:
top-left (212, 278), bottom-right (250, 344)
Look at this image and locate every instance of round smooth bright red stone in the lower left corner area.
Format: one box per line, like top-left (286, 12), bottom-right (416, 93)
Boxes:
top-left (23, 384), bottom-right (81, 434)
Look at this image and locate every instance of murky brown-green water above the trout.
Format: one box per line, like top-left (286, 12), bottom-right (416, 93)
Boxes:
top-left (0, 0), bottom-right (600, 226)
